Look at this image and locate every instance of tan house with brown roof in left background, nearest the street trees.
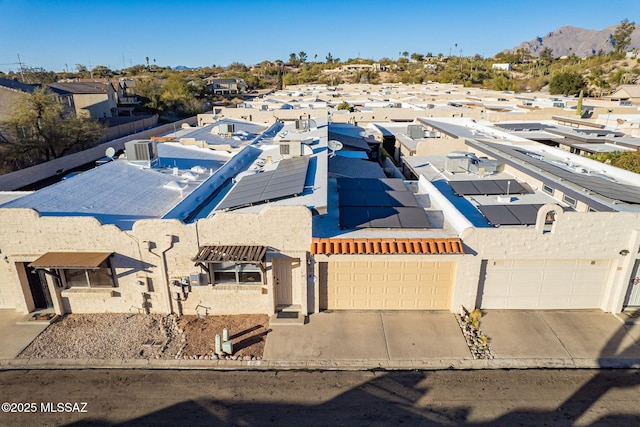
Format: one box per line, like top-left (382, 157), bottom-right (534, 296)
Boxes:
top-left (49, 82), bottom-right (118, 119)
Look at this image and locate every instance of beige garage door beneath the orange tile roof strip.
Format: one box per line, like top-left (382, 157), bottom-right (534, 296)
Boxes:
top-left (321, 261), bottom-right (453, 310)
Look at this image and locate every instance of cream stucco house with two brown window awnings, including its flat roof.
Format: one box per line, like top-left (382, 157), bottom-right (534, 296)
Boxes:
top-left (0, 118), bottom-right (327, 320)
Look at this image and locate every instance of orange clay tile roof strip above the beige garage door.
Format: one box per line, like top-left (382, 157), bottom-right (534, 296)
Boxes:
top-left (311, 238), bottom-right (464, 255)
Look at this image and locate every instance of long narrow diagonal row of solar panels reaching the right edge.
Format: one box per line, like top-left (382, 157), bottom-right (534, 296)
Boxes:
top-left (486, 142), bottom-right (640, 204)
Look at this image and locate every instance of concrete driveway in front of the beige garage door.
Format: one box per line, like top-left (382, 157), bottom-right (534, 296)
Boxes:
top-left (264, 311), bottom-right (472, 361)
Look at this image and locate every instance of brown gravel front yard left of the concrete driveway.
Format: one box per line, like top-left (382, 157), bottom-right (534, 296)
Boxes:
top-left (19, 314), bottom-right (269, 360)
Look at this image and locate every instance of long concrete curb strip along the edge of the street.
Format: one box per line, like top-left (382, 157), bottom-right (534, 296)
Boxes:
top-left (0, 358), bottom-right (640, 371)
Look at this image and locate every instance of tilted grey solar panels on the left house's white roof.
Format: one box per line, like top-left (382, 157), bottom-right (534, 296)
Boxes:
top-left (216, 156), bottom-right (309, 209)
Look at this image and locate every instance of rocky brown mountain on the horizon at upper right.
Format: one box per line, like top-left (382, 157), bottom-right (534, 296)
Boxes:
top-left (506, 25), bottom-right (640, 57)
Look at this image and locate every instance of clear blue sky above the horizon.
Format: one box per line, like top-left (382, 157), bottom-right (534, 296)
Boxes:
top-left (0, 0), bottom-right (640, 72)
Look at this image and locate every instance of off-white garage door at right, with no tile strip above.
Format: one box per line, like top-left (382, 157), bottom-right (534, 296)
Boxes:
top-left (481, 260), bottom-right (611, 309)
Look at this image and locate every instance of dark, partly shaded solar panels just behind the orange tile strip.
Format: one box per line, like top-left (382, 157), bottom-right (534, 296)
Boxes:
top-left (337, 178), bottom-right (431, 229)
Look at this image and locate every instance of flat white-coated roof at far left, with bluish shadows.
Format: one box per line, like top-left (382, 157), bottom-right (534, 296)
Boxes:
top-left (0, 143), bottom-right (231, 230)
